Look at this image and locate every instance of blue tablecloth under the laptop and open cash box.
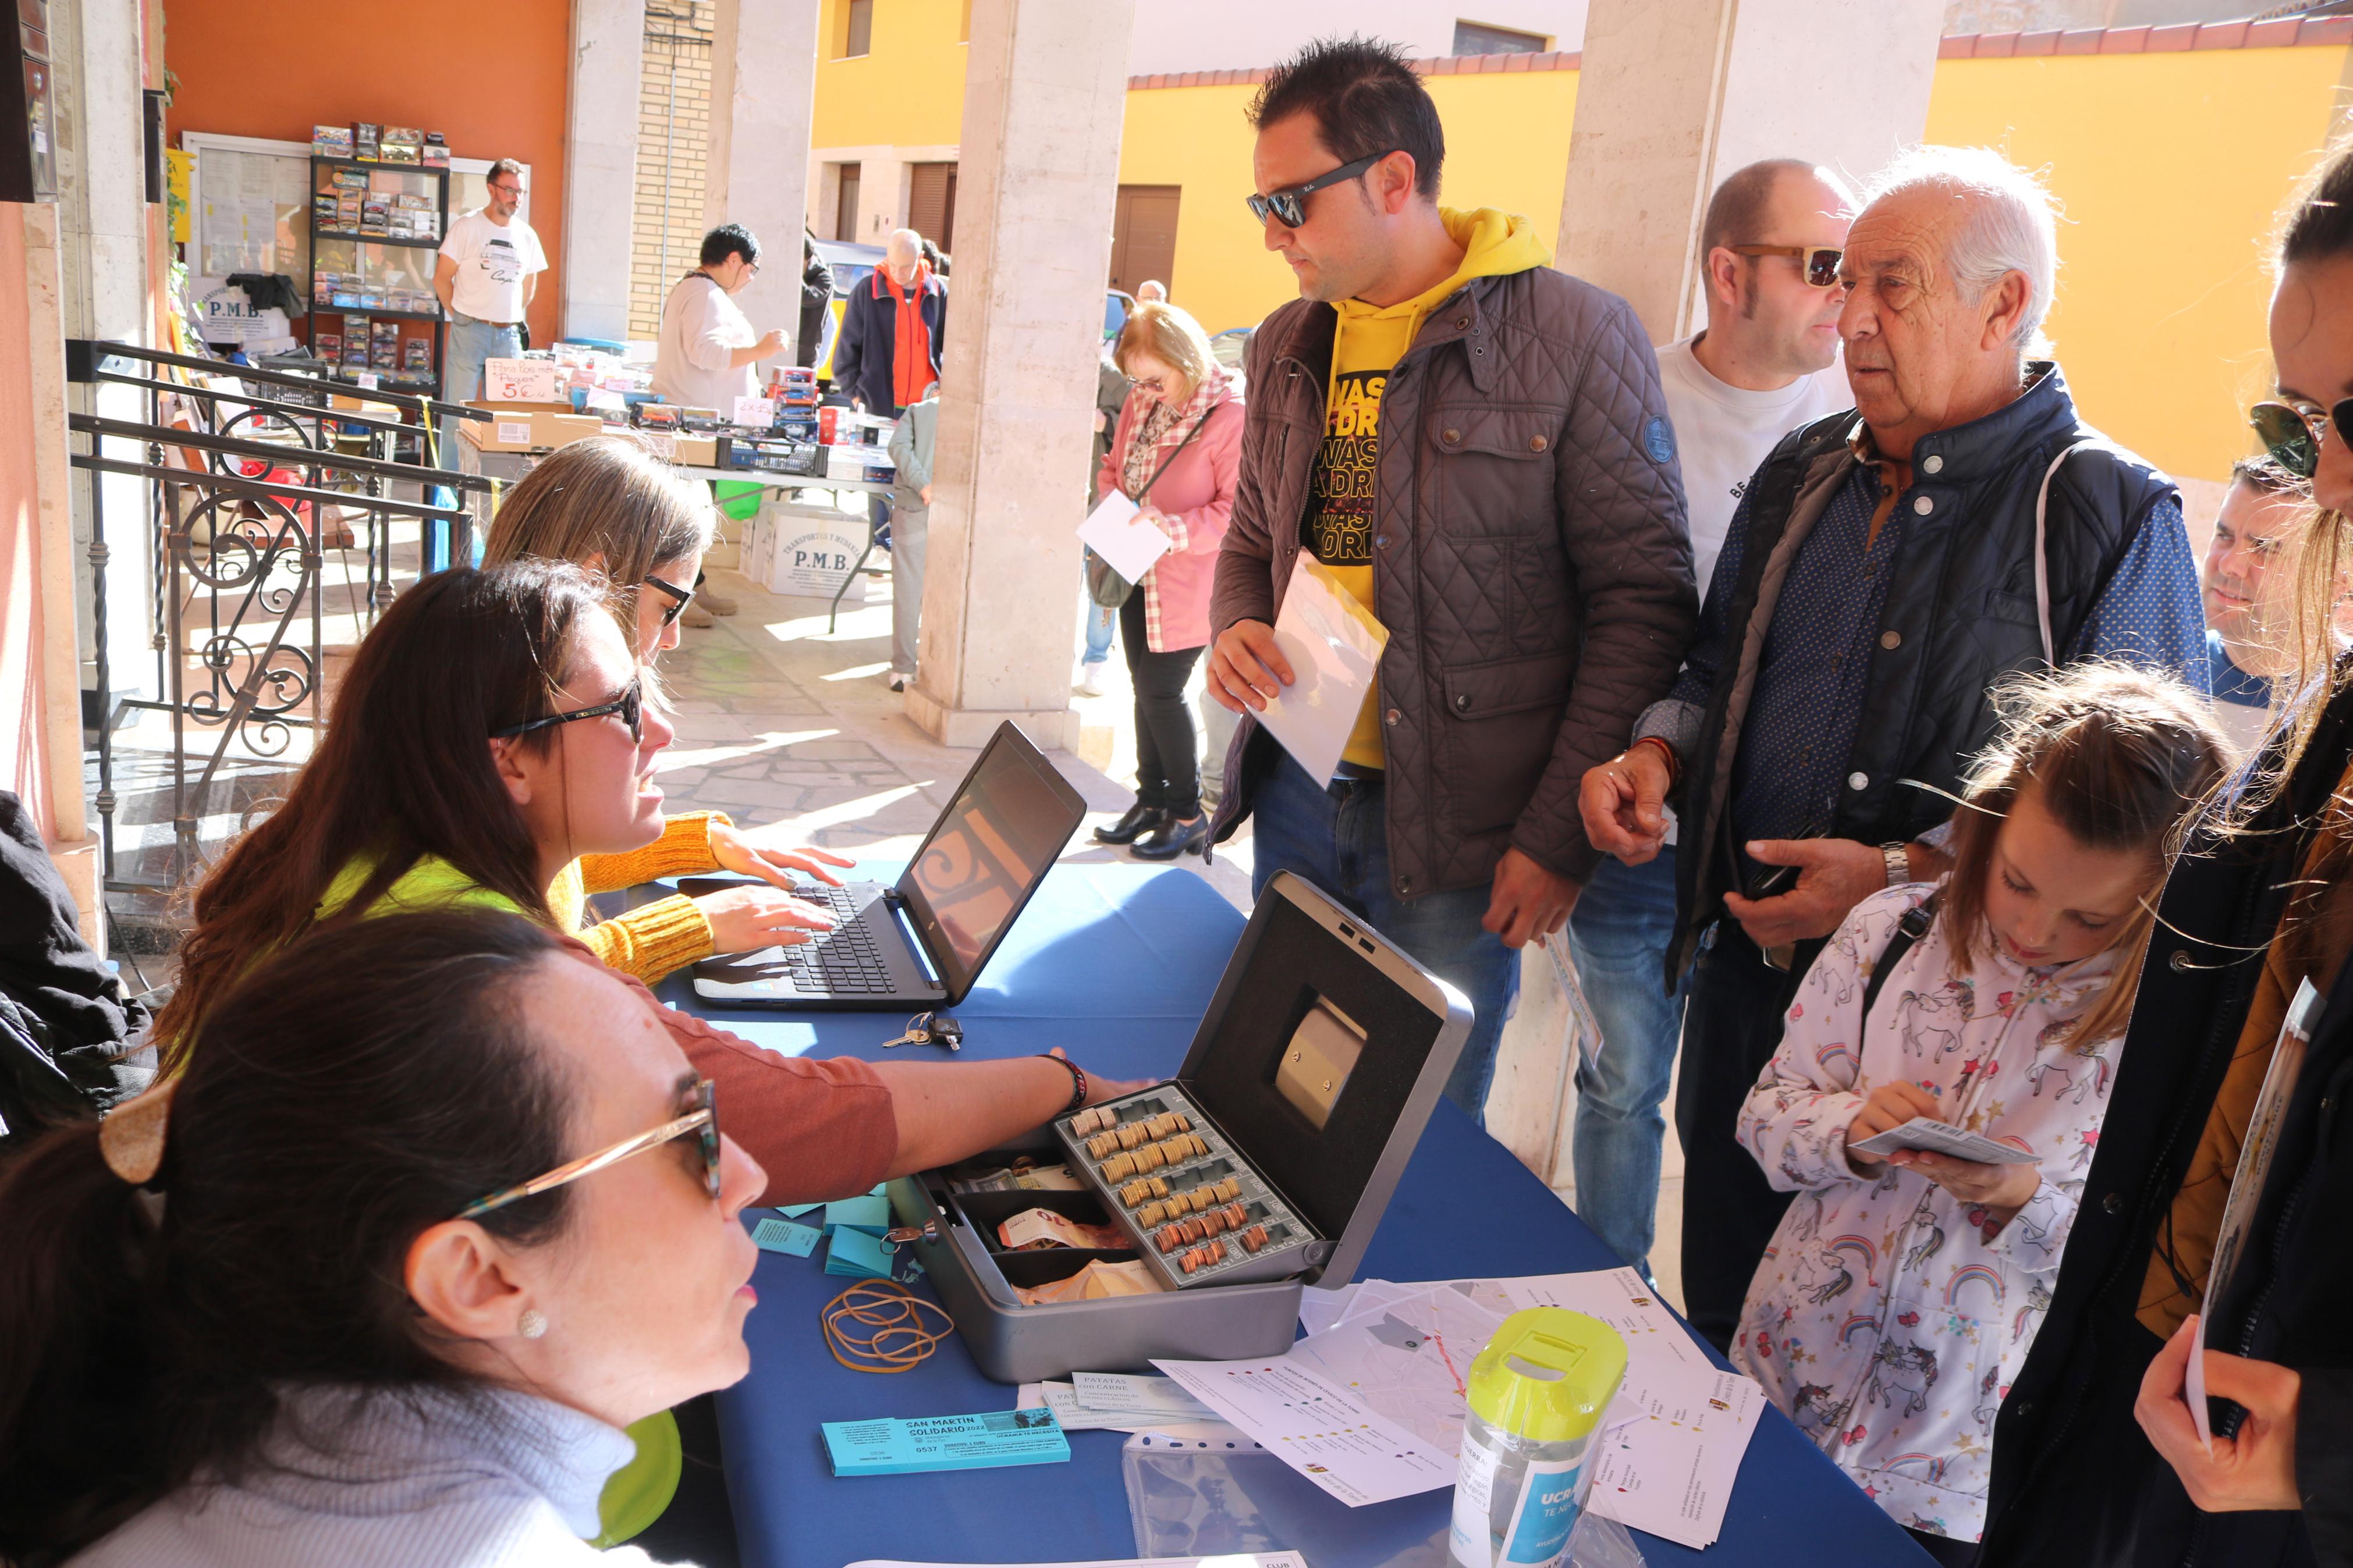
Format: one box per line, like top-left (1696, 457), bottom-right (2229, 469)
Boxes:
top-left (659, 865), bottom-right (1927, 1568)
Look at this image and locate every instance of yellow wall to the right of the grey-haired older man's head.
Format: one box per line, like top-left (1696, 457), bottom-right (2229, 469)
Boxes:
top-left (1927, 49), bottom-right (2346, 479)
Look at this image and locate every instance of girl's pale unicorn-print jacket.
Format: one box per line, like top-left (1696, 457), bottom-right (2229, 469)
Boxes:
top-left (1731, 884), bottom-right (2123, 1540)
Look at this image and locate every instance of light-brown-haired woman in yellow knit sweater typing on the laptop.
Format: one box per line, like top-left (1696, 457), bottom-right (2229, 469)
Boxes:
top-left (482, 435), bottom-right (852, 985)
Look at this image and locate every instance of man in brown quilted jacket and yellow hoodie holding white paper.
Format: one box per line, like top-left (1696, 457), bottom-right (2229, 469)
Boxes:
top-left (1209, 38), bottom-right (1697, 1114)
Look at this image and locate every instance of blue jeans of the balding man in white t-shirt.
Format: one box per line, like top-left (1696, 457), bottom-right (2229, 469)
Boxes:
top-left (1570, 844), bottom-right (1687, 1274)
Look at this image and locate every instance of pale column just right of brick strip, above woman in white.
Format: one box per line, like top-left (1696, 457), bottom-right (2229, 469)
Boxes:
top-left (704, 0), bottom-right (819, 364)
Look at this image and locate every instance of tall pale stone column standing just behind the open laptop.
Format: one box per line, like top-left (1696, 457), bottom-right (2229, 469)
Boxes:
top-left (908, 0), bottom-right (1134, 750)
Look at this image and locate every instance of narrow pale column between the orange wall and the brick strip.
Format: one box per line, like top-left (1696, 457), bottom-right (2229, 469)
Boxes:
top-left (560, 0), bottom-right (645, 341)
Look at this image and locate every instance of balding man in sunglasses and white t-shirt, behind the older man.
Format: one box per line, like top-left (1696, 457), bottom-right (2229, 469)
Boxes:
top-left (1570, 158), bottom-right (1854, 1274)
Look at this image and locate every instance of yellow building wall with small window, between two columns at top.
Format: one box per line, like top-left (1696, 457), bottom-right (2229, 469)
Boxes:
top-left (809, 0), bottom-right (965, 148)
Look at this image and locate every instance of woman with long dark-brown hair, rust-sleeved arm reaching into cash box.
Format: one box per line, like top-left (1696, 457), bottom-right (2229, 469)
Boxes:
top-left (158, 562), bottom-right (1132, 1204)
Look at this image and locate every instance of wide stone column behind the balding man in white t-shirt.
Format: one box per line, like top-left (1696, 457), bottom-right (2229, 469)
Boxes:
top-left (1555, 0), bottom-right (1944, 343)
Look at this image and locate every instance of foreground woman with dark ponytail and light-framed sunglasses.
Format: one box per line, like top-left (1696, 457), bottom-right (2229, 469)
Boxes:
top-left (0, 912), bottom-right (767, 1568)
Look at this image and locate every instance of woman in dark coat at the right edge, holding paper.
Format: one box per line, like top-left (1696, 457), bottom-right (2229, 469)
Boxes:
top-left (1983, 146), bottom-right (2353, 1568)
